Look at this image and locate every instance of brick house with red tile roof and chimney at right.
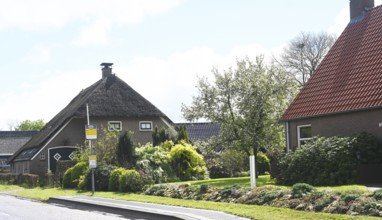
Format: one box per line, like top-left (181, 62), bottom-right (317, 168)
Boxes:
top-left (281, 0), bottom-right (382, 151)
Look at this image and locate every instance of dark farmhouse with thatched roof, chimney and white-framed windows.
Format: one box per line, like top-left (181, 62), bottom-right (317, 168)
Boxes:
top-left (9, 63), bottom-right (173, 175)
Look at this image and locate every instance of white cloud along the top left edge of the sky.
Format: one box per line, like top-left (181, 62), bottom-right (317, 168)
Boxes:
top-left (0, 0), bottom-right (181, 30)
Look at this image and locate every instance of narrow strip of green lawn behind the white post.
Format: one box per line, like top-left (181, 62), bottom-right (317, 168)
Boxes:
top-left (170, 175), bottom-right (275, 187)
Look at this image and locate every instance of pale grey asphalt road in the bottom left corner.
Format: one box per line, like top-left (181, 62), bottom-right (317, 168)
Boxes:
top-left (0, 195), bottom-right (126, 220)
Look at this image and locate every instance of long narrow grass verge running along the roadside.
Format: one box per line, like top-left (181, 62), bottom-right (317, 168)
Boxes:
top-left (0, 185), bottom-right (381, 220)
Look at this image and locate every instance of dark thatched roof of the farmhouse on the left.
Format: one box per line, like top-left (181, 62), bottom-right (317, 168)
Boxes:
top-left (10, 74), bottom-right (172, 161)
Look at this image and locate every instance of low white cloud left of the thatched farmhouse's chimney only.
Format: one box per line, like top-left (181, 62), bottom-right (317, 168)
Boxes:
top-left (0, 70), bottom-right (101, 130)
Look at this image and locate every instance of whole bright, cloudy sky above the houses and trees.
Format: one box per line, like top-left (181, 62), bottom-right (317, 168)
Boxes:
top-left (0, 0), bottom-right (382, 130)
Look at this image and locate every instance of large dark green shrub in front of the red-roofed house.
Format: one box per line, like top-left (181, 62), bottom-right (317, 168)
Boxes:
top-left (276, 133), bottom-right (378, 185)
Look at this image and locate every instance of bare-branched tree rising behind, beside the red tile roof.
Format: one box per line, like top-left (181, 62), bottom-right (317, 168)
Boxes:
top-left (275, 32), bottom-right (336, 87)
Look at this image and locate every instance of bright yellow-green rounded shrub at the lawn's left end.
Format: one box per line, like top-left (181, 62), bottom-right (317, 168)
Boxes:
top-left (169, 142), bottom-right (208, 180)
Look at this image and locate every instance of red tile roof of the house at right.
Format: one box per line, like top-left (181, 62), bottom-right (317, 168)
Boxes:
top-left (281, 6), bottom-right (382, 121)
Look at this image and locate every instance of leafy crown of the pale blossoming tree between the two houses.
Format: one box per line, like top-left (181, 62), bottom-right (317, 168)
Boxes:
top-left (182, 57), bottom-right (296, 160)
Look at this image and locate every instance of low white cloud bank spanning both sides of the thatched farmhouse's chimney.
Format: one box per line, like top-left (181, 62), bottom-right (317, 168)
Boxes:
top-left (0, 41), bottom-right (284, 129)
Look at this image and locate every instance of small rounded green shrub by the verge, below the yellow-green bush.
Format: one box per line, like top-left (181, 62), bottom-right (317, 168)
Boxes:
top-left (119, 170), bottom-right (145, 192)
